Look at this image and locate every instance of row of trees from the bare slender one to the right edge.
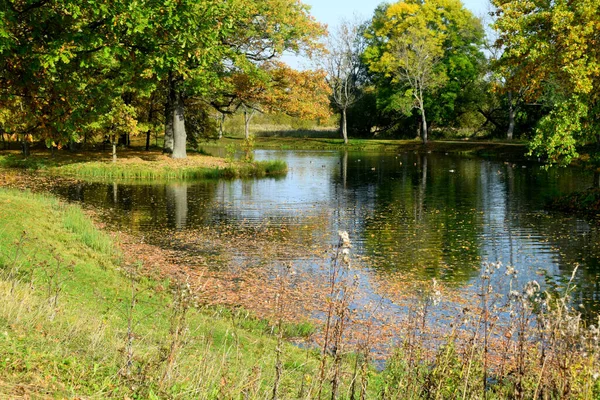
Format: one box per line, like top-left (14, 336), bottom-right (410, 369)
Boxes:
top-left (325, 0), bottom-right (600, 164)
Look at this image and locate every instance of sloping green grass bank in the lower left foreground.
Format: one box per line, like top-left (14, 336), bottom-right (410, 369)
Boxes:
top-left (0, 189), bottom-right (346, 399)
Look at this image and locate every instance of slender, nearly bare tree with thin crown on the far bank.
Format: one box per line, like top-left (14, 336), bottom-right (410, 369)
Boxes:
top-left (324, 19), bottom-right (365, 144)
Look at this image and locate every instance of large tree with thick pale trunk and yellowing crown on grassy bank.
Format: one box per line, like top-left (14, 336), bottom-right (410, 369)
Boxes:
top-left (145, 0), bottom-right (322, 158)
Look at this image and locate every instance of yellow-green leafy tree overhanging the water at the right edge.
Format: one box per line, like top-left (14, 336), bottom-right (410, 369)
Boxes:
top-left (493, 0), bottom-right (600, 165)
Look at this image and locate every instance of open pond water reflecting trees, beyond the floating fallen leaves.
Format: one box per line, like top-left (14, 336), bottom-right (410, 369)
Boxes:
top-left (55, 150), bottom-right (600, 318)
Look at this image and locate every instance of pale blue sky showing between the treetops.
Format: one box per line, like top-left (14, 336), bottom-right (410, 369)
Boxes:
top-left (284, 0), bottom-right (489, 68)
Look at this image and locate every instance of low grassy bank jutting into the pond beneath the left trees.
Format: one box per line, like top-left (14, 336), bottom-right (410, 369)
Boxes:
top-left (0, 151), bottom-right (287, 180)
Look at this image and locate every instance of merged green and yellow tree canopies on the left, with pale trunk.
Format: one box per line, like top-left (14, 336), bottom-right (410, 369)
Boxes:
top-left (0, 0), bottom-right (324, 157)
